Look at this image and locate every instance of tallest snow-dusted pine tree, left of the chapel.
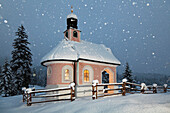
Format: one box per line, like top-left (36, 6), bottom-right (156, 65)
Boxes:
top-left (11, 25), bottom-right (32, 94)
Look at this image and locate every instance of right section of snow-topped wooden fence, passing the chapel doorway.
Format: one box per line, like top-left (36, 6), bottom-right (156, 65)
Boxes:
top-left (92, 81), bottom-right (170, 100)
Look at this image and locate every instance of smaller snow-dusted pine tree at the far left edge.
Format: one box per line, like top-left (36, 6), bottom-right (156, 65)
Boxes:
top-left (1, 60), bottom-right (12, 97)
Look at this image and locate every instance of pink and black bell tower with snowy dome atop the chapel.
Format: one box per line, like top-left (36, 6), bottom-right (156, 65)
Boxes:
top-left (64, 7), bottom-right (81, 42)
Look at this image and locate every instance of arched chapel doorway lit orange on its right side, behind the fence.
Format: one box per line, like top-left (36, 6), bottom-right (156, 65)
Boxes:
top-left (101, 68), bottom-right (114, 93)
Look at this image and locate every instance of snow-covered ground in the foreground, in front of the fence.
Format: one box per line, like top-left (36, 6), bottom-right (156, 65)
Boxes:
top-left (0, 93), bottom-right (170, 113)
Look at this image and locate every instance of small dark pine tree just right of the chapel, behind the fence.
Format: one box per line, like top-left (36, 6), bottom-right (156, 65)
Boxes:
top-left (123, 63), bottom-right (133, 82)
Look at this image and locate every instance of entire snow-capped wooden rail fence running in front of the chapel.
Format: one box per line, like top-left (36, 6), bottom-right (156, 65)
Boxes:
top-left (22, 80), bottom-right (170, 106)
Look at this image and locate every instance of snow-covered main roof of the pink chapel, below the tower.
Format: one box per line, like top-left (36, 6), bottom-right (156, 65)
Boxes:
top-left (41, 39), bottom-right (120, 65)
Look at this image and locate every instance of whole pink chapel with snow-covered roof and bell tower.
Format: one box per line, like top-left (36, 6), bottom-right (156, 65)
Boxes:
top-left (41, 10), bottom-right (120, 96)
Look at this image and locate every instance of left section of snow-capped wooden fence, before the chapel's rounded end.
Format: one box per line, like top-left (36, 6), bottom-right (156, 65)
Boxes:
top-left (22, 83), bottom-right (75, 106)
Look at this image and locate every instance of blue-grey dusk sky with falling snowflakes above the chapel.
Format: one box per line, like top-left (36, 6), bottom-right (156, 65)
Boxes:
top-left (0, 0), bottom-right (170, 74)
